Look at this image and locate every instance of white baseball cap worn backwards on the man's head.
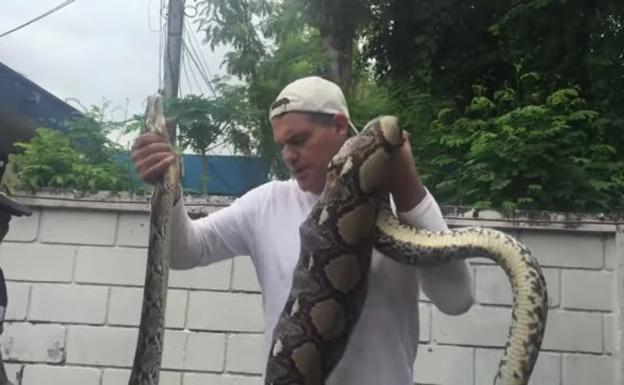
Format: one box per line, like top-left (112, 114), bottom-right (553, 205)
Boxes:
top-left (269, 76), bottom-right (358, 134)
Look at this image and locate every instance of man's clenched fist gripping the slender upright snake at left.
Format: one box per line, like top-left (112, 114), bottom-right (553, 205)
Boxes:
top-left (132, 132), bottom-right (176, 184)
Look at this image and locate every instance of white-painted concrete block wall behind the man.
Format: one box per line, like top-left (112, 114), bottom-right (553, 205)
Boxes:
top-left (0, 192), bottom-right (624, 385)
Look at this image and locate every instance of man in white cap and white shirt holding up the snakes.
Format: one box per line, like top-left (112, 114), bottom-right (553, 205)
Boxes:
top-left (133, 77), bottom-right (472, 385)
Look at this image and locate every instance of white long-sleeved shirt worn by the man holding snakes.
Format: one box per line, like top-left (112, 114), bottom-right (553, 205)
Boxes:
top-left (171, 179), bottom-right (471, 385)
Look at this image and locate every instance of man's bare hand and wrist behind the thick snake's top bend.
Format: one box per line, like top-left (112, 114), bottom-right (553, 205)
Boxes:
top-left (388, 132), bottom-right (426, 212)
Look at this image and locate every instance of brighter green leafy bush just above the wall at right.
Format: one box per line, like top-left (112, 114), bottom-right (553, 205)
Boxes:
top-left (417, 73), bottom-right (624, 211)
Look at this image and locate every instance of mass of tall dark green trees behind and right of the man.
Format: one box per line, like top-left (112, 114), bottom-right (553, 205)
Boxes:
top-left (184, 0), bottom-right (624, 211)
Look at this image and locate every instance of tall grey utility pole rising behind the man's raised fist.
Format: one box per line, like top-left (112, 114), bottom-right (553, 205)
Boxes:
top-left (164, 0), bottom-right (185, 146)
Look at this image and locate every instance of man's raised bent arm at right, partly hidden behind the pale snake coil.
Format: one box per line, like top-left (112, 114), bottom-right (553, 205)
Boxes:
top-left (390, 137), bottom-right (474, 315)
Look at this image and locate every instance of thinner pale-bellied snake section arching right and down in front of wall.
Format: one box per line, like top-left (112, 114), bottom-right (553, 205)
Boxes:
top-left (375, 204), bottom-right (548, 385)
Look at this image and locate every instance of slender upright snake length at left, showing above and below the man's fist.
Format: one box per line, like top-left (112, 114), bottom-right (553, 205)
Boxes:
top-left (129, 95), bottom-right (178, 385)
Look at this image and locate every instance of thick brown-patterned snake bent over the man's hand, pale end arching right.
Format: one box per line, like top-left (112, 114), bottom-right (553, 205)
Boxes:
top-left (265, 117), bottom-right (548, 385)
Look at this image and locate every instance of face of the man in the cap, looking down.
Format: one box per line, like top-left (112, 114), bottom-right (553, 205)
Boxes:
top-left (271, 112), bottom-right (348, 194)
